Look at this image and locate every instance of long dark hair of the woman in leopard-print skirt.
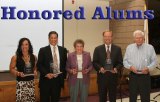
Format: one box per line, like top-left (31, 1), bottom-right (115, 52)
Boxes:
top-left (16, 38), bottom-right (33, 57)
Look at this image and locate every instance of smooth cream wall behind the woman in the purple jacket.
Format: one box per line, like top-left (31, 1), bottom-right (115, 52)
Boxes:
top-left (64, 0), bottom-right (109, 56)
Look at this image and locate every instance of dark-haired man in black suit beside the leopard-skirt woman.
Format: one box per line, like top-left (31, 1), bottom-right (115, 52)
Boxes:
top-left (37, 31), bottom-right (67, 102)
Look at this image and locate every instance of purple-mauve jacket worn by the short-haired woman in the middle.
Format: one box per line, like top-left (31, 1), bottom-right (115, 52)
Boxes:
top-left (66, 51), bottom-right (92, 85)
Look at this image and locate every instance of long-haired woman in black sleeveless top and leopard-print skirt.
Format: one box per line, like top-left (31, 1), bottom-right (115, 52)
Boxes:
top-left (10, 38), bottom-right (37, 102)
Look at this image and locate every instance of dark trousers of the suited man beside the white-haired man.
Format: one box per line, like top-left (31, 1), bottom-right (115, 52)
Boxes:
top-left (98, 73), bottom-right (117, 102)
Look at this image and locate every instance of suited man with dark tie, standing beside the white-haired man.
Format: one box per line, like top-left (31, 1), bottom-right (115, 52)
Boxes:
top-left (93, 31), bottom-right (123, 102)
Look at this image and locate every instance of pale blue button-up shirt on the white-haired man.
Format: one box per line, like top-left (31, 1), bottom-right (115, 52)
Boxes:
top-left (123, 43), bottom-right (157, 71)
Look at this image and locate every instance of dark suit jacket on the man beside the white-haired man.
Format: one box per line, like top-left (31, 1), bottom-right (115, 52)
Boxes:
top-left (93, 44), bottom-right (123, 82)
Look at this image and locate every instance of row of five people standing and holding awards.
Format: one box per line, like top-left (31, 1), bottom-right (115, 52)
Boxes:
top-left (10, 30), bottom-right (157, 102)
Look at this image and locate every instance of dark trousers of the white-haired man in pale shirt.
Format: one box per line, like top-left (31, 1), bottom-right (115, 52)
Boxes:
top-left (129, 73), bottom-right (151, 102)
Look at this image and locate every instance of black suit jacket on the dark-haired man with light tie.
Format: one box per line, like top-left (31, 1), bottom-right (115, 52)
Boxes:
top-left (37, 46), bottom-right (67, 87)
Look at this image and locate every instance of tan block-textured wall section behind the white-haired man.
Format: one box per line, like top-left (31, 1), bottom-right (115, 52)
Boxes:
top-left (109, 0), bottom-right (145, 54)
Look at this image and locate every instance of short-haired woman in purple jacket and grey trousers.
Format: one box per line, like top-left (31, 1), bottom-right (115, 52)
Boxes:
top-left (66, 39), bottom-right (92, 102)
